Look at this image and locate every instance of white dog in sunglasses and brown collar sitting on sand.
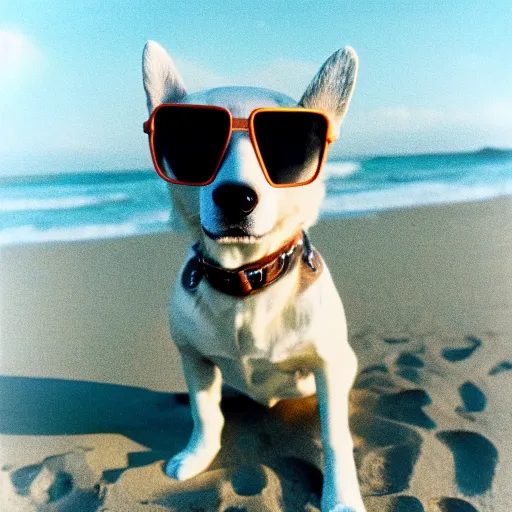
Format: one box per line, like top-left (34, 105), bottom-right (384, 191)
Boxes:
top-left (143, 41), bottom-right (365, 512)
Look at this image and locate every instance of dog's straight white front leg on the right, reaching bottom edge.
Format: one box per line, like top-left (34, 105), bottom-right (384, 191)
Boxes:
top-left (315, 358), bottom-right (365, 512)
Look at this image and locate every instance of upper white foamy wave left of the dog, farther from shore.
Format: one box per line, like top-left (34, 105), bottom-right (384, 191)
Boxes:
top-left (0, 192), bottom-right (131, 213)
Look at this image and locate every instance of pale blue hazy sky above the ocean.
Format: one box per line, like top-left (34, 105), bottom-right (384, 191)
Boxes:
top-left (0, 0), bottom-right (512, 176)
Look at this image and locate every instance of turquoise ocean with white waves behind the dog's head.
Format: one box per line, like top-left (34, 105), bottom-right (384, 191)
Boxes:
top-left (0, 148), bottom-right (512, 245)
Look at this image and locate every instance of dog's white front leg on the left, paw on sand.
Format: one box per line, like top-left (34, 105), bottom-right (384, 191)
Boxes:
top-left (165, 347), bottom-right (224, 480)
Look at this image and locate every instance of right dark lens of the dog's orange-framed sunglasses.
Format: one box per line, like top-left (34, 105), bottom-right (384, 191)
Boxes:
top-left (254, 111), bottom-right (328, 185)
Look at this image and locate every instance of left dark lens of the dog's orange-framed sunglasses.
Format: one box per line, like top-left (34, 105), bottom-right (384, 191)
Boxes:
top-left (153, 105), bottom-right (230, 184)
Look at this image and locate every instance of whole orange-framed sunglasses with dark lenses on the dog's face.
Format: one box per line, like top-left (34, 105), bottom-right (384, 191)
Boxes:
top-left (144, 103), bottom-right (335, 187)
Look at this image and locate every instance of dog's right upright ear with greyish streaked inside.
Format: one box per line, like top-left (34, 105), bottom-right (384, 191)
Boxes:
top-left (299, 46), bottom-right (358, 135)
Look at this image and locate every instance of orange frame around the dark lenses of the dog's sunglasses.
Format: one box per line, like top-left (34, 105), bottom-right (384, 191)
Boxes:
top-left (144, 103), bottom-right (336, 188)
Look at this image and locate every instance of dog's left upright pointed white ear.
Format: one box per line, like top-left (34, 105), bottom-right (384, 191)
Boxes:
top-left (142, 41), bottom-right (187, 114)
